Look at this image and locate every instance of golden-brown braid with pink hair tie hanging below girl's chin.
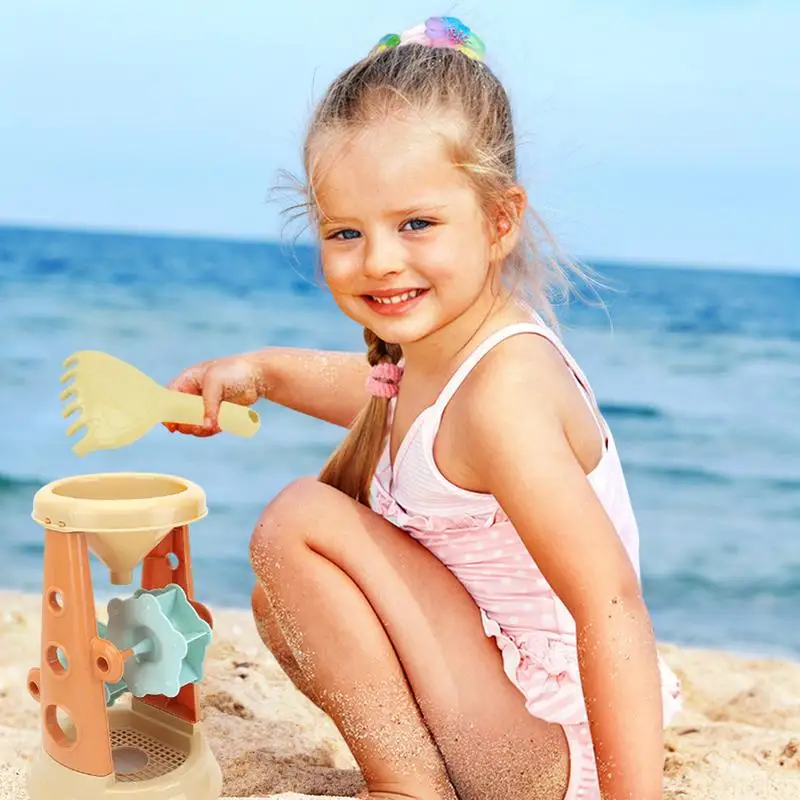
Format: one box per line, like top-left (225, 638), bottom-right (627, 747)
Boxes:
top-left (319, 328), bottom-right (403, 507)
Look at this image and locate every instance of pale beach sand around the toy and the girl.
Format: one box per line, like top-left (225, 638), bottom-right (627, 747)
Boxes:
top-left (0, 592), bottom-right (800, 800)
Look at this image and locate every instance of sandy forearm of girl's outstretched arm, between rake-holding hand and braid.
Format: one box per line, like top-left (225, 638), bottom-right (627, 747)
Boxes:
top-left (252, 347), bottom-right (370, 428)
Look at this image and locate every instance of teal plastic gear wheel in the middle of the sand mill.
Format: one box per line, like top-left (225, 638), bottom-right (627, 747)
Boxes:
top-left (101, 583), bottom-right (211, 702)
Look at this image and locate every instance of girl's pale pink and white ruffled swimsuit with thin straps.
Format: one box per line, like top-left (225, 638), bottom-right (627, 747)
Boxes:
top-left (372, 319), bottom-right (681, 800)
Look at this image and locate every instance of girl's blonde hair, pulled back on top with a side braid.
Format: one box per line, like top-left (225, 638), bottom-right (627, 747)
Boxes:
top-left (286, 44), bottom-right (582, 506)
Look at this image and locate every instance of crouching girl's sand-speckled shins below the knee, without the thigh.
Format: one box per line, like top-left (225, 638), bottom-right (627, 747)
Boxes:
top-left (251, 479), bottom-right (456, 800)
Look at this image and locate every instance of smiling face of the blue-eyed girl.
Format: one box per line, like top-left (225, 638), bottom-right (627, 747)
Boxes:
top-left (315, 119), bottom-right (506, 345)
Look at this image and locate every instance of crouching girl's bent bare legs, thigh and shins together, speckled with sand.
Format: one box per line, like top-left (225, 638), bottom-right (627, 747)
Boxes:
top-left (251, 479), bottom-right (569, 800)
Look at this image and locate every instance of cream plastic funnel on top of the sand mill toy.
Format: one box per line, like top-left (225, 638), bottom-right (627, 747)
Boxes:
top-left (32, 472), bottom-right (208, 584)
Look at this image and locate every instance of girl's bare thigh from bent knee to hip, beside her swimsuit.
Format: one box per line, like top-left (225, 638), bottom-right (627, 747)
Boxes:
top-left (251, 479), bottom-right (569, 800)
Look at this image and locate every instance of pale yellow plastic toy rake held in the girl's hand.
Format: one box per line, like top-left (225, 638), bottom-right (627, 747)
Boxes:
top-left (61, 350), bottom-right (261, 456)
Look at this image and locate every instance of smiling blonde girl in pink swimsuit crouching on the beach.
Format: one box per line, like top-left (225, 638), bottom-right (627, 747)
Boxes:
top-left (168, 18), bottom-right (679, 800)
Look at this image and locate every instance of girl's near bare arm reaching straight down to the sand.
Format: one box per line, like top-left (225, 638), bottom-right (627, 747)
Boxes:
top-left (459, 337), bottom-right (664, 800)
